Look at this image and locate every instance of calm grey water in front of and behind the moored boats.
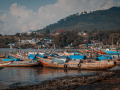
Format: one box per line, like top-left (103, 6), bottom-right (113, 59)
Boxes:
top-left (0, 48), bottom-right (120, 90)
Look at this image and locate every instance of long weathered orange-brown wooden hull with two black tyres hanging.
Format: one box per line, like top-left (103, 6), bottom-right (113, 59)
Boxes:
top-left (40, 59), bottom-right (115, 70)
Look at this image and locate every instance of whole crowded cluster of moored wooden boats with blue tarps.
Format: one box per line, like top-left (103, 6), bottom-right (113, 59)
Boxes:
top-left (0, 47), bottom-right (120, 70)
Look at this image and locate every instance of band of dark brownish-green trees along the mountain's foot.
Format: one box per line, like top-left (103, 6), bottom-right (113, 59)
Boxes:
top-left (0, 29), bottom-right (120, 48)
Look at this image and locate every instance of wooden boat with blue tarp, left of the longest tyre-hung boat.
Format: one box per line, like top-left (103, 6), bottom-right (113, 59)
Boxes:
top-left (3, 57), bottom-right (40, 67)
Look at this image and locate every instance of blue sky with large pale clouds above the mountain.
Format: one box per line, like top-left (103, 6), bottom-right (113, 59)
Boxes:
top-left (0, 0), bottom-right (120, 35)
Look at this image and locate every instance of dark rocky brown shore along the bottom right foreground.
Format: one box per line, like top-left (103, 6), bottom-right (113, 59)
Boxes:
top-left (7, 70), bottom-right (120, 90)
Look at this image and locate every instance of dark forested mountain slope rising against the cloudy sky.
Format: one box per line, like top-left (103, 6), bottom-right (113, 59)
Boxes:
top-left (37, 6), bottom-right (120, 32)
